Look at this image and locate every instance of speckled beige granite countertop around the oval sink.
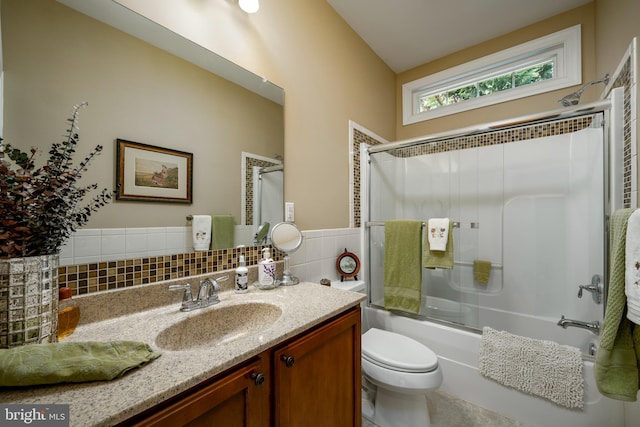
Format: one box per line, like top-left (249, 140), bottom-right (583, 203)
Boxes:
top-left (0, 275), bottom-right (364, 427)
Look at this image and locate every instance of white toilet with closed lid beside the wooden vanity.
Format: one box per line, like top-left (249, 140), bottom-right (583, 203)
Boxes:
top-left (362, 328), bottom-right (442, 427)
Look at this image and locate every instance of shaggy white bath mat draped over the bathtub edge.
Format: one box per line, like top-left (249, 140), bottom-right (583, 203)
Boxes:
top-left (478, 327), bottom-right (584, 409)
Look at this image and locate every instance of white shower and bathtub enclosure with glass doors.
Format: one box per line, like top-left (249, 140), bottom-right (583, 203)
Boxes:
top-left (362, 87), bottom-right (623, 427)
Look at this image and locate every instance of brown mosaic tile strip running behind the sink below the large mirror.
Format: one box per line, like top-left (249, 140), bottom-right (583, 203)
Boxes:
top-left (58, 245), bottom-right (284, 295)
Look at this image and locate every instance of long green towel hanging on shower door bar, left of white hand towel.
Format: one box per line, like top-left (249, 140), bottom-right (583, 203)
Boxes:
top-left (384, 220), bottom-right (422, 313)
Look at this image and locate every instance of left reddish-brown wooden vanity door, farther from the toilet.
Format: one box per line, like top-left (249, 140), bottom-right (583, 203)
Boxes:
top-left (133, 358), bottom-right (270, 427)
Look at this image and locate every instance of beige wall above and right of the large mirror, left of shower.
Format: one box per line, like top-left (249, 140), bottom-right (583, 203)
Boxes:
top-left (114, 0), bottom-right (396, 230)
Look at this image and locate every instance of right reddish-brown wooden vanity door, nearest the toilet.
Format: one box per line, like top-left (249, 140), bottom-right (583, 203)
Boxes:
top-left (272, 306), bottom-right (362, 427)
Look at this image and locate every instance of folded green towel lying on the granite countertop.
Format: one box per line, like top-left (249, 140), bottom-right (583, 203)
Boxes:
top-left (0, 341), bottom-right (160, 387)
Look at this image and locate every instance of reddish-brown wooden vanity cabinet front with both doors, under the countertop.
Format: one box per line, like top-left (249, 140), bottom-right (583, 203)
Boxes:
top-left (125, 307), bottom-right (361, 426)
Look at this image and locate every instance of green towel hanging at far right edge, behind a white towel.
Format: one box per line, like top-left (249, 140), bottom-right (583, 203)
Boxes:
top-left (593, 209), bottom-right (640, 402)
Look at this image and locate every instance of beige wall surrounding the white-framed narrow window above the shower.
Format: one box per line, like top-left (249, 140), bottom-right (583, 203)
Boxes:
top-left (396, 3), bottom-right (602, 140)
